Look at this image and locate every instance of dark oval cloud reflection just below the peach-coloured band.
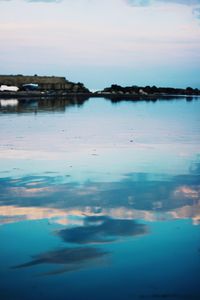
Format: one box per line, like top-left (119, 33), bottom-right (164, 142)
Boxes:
top-left (58, 216), bottom-right (147, 244)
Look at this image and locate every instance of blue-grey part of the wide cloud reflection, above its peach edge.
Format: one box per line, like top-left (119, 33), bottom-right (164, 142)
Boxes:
top-left (0, 171), bottom-right (200, 216)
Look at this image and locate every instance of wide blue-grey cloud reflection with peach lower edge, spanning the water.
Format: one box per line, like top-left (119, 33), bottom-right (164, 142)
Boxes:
top-left (0, 167), bottom-right (200, 224)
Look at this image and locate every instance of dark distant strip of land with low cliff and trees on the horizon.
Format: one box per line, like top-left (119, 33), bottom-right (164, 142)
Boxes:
top-left (0, 75), bottom-right (200, 100)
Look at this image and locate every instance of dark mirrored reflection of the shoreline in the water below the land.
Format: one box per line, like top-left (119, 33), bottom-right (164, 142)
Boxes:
top-left (0, 94), bottom-right (200, 114)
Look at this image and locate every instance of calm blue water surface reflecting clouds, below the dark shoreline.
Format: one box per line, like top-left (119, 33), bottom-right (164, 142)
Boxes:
top-left (0, 98), bottom-right (200, 300)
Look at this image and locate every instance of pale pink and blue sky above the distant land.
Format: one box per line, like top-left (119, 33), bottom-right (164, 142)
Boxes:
top-left (0, 0), bottom-right (200, 90)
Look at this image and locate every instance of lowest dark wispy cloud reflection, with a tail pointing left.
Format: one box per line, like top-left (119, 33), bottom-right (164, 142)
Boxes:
top-left (13, 247), bottom-right (108, 275)
